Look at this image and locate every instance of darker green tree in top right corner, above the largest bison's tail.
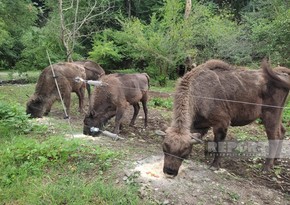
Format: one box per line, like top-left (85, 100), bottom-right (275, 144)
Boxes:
top-left (243, 0), bottom-right (290, 66)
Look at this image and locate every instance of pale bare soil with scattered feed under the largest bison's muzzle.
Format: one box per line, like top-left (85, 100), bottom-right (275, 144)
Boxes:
top-left (133, 155), bottom-right (288, 204)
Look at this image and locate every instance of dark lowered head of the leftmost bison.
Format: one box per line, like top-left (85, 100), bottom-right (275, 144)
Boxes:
top-left (26, 97), bottom-right (44, 118)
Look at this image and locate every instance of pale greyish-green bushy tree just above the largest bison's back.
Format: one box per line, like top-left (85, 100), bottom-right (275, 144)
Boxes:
top-left (189, 4), bottom-right (252, 64)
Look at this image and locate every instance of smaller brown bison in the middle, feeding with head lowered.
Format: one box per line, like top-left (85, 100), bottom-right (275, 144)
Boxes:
top-left (83, 73), bottom-right (149, 135)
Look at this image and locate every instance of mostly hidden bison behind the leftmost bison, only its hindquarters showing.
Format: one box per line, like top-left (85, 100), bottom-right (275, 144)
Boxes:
top-left (73, 60), bottom-right (105, 96)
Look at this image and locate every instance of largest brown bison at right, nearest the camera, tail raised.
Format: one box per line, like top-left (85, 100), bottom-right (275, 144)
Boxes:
top-left (163, 60), bottom-right (290, 176)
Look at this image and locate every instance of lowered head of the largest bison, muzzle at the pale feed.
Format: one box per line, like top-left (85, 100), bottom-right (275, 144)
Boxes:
top-left (163, 128), bottom-right (200, 176)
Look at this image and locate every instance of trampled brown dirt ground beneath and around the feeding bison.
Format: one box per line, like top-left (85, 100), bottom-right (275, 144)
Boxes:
top-left (43, 92), bottom-right (290, 205)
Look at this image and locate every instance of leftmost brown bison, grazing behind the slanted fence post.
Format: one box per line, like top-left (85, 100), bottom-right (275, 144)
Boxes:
top-left (26, 63), bottom-right (86, 118)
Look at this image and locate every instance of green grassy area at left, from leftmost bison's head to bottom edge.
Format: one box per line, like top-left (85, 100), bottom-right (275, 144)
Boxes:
top-left (0, 85), bottom-right (146, 204)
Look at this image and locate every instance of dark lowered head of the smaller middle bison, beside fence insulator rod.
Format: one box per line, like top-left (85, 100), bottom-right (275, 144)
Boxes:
top-left (83, 104), bottom-right (116, 136)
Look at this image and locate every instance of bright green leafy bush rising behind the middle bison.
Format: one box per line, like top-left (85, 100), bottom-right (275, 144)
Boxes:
top-left (90, 0), bottom-right (195, 81)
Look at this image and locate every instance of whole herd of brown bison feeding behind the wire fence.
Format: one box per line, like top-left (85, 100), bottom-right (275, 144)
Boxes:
top-left (26, 60), bottom-right (290, 191)
